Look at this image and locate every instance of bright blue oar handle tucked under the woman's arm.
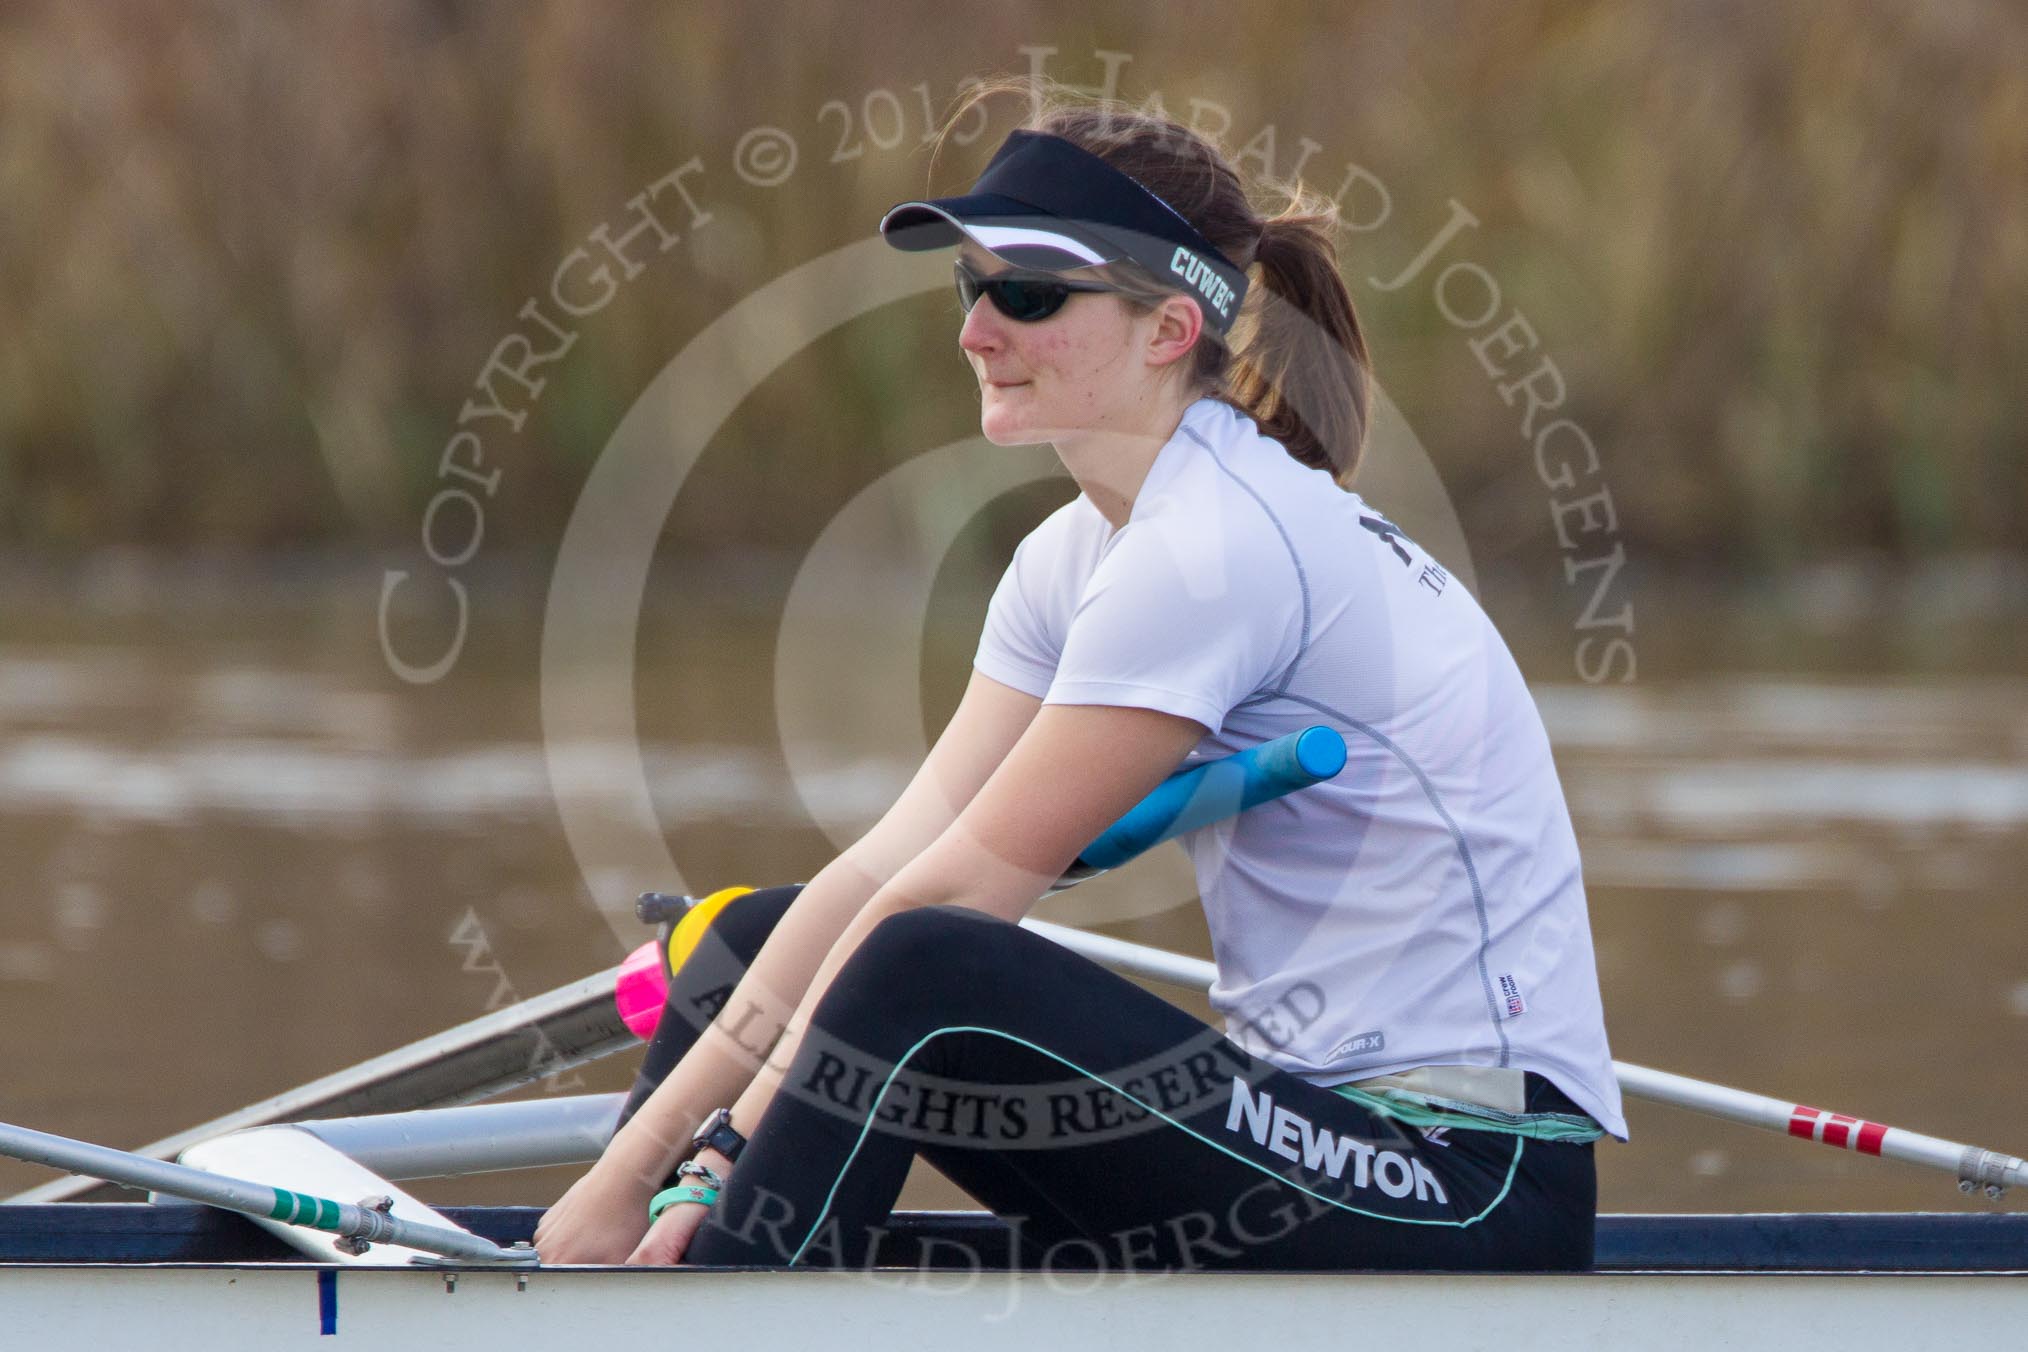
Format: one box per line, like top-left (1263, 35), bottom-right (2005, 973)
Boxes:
top-left (1065, 726), bottom-right (1345, 878)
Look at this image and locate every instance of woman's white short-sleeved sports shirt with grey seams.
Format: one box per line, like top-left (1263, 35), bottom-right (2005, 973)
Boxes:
top-left (975, 399), bottom-right (1626, 1137)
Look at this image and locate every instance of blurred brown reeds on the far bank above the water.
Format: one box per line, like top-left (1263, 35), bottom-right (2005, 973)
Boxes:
top-left (0, 0), bottom-right (2028, 574)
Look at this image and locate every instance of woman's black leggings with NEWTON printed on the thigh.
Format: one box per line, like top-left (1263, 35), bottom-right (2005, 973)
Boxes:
top-left (621, 888), bottom-right (1598, 1271)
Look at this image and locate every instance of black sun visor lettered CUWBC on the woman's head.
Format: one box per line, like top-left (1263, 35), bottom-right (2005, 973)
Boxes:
top-left (880, 132), bottom-right (1247, 334)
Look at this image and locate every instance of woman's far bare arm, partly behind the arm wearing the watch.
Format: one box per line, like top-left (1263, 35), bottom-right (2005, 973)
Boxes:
top-left (588, 673), bottom-right (1040, 1182)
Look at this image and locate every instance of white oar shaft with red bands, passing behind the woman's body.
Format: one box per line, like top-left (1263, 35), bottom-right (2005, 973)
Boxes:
top-left (1022, 920), bottom-right (2028, 1196)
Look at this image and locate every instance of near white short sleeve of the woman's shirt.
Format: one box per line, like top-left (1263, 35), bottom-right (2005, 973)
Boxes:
top-left (1044, 514), bottom-right (1302, 732)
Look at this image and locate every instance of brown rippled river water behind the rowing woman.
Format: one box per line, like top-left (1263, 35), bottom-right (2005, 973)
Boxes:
top-left (0, 559), bottom-right (2028, 1210)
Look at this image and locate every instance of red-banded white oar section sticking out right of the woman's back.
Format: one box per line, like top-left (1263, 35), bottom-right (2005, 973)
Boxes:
top-left (1612, 1060), bottom-right (2028, 1200)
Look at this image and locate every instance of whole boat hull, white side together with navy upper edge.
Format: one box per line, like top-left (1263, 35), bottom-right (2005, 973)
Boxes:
top-left (0, 1204), bottom-right (2028, 1352)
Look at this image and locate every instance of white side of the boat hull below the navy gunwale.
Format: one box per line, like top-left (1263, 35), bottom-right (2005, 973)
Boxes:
top-left (0, 1265), bottom-right (2028, 1352)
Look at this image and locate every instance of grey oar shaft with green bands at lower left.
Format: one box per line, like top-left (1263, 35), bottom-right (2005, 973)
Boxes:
top-left (0, 1123), bottom-right (521, 1263)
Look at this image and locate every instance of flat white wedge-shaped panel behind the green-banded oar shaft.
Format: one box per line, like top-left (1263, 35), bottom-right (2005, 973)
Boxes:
top-left (178, 1127), bottom-right (470, 1267)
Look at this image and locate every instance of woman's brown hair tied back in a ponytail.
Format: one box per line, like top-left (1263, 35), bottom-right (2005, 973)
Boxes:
top-left (931, 77), bottom-right (1371, 484)
